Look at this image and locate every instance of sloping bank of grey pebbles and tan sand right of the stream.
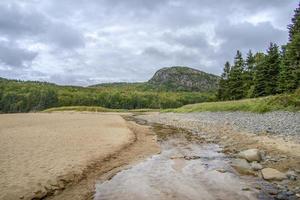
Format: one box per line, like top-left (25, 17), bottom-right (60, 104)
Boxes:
top-left (138, 112), bottom-right (300, 198)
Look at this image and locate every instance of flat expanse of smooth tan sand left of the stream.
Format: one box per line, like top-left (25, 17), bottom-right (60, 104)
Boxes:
top-left (0, 113), bottom-right (135, 199)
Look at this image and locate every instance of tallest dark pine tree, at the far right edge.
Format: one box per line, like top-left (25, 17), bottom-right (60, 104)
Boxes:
top-left (279, 3), bottom-right (300, 92)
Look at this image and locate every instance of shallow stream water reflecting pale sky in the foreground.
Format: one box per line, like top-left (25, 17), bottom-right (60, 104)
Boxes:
top-left (94, 122), bottom-right (272, 200)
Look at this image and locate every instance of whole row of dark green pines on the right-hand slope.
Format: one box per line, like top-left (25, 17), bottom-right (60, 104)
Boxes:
top-left (217, 3), bottom-right (300, 100)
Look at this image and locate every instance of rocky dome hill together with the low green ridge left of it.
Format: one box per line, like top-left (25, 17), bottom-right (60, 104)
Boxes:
top-left (90, 66), bottom-right (219, 92)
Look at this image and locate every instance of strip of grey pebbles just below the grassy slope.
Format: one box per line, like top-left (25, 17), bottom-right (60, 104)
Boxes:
top-left (141, 111), bottom-right (300, 138)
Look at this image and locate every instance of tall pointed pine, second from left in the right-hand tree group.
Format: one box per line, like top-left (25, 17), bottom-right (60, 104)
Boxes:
top-left (228, 50), bottom-right (245, 100)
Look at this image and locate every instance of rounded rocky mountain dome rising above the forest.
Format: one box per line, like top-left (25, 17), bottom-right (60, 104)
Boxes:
top-left (148, 66), bottom-right (220, 91)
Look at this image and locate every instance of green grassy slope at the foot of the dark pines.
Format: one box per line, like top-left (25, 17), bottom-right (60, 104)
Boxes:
top-left (164, 89), bottom-right (300, 113)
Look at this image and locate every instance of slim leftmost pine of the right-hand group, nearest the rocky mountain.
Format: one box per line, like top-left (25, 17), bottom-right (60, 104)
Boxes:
top-left (217, 61), bottom-right (230, 100)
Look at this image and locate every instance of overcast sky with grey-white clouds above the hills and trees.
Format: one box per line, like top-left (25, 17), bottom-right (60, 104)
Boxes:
top-left (0, 0), bottom-right (298, 85)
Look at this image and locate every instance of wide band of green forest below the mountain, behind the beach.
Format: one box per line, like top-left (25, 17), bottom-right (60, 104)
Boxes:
top-left (0, 78), bottom-right (215, 113)
